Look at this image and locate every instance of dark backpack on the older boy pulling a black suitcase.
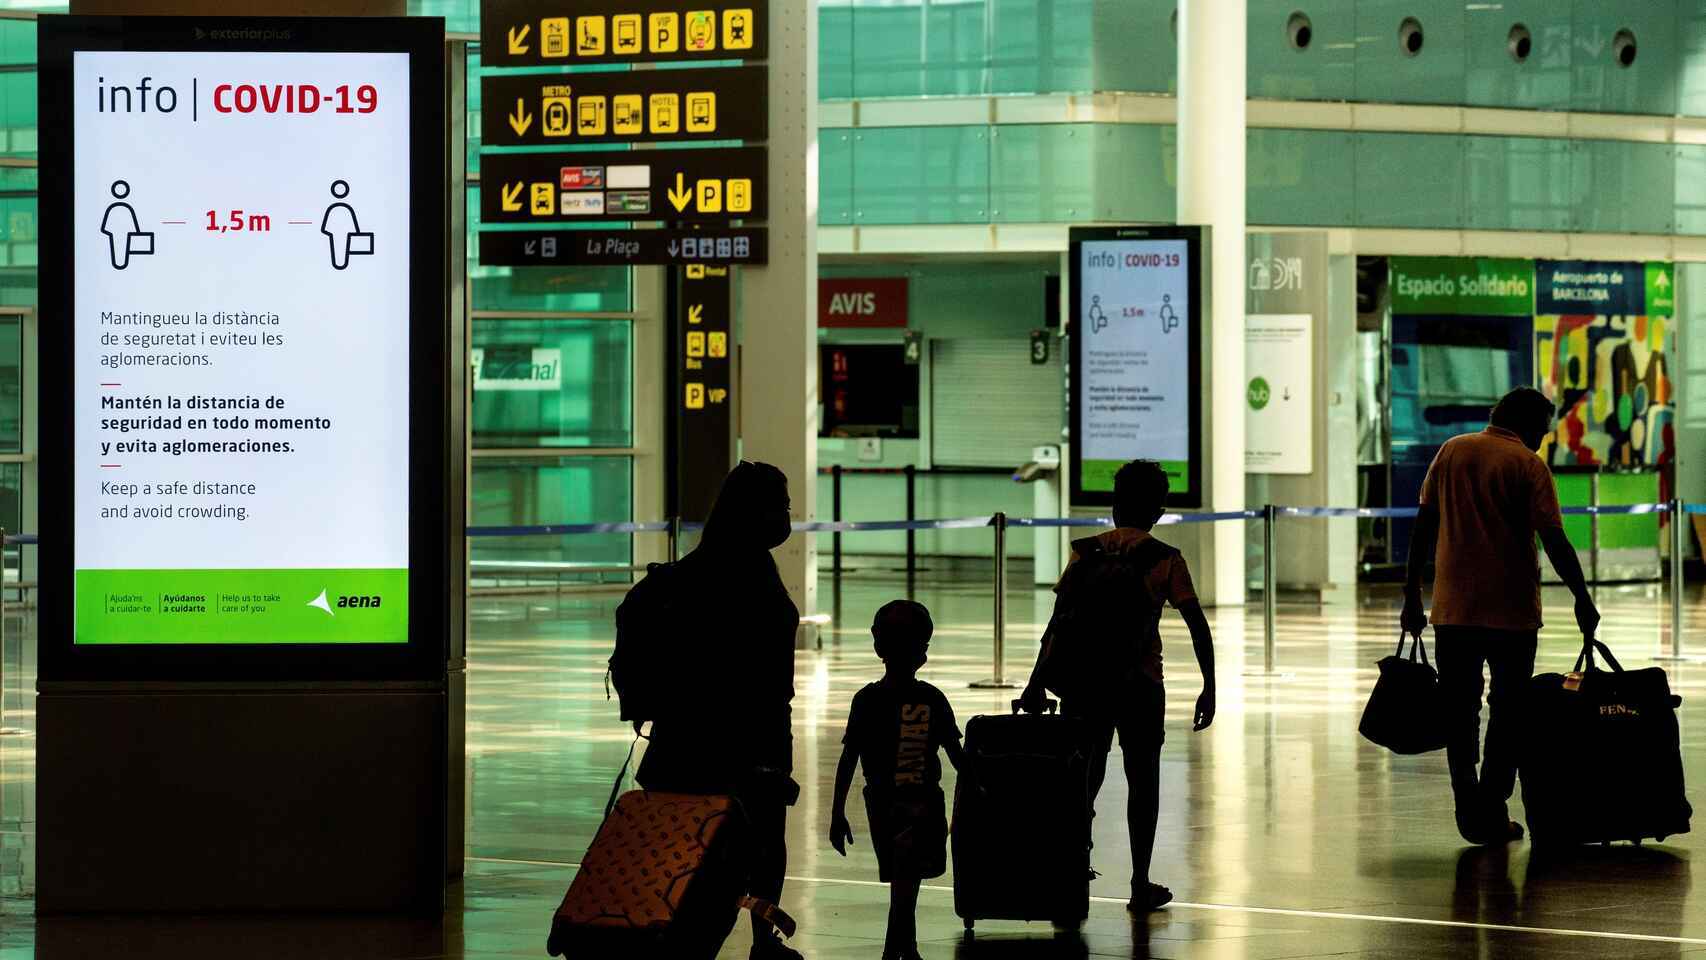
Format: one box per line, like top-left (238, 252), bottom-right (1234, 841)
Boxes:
top-left (1037, 537), bottom-right (1179, 703)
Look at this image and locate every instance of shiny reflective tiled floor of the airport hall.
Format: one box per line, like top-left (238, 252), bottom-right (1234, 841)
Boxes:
top-left (0, 581), bottom-right (1706, 960)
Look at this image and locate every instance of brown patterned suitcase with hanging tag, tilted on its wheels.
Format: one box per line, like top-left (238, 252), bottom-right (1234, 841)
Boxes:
top-left (546, 789), bottom-right (793, 960)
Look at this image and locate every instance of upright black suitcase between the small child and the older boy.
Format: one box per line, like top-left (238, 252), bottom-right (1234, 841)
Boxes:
top-left (952, 701), bottom-right (1090, 934)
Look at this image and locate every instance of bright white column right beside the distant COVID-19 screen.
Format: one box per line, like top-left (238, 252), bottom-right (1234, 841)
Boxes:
top-left (1179, 0), bottom-right (1245, 604)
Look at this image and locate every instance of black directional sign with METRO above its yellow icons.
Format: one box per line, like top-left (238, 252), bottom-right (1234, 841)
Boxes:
top-left (479, 67), bottom-right (769, 147)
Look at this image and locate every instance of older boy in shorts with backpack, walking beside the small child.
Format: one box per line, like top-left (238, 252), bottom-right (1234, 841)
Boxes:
top-left (1022, 460), bottom-right (1215, 914)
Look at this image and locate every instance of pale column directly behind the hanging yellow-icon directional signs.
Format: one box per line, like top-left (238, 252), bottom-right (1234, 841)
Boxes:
top-left (739, 0), bottom-right (817, 639)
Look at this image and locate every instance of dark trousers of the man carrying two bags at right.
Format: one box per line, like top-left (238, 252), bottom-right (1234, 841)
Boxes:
top-left (1433, 626), bottom-right (1537, 829)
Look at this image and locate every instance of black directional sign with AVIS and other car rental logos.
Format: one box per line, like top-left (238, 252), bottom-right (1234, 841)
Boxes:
top-left (479, 147), bottom-right (768, 227)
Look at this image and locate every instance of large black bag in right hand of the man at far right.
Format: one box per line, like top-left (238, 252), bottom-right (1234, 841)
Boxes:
top-left (1520, 639), bottom-right (1694, 844)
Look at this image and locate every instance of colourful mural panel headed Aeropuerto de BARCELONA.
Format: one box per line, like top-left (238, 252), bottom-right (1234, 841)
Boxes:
top-left (1534, 261), bottom-right (1675, 469)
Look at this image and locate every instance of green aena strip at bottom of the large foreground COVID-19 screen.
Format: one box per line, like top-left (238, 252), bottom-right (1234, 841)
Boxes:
top-left (75, 570), bottom-right (409, 645)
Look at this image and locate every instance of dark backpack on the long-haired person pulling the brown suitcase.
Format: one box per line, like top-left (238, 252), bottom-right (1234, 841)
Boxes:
top-left (606, 563), bottom-right (684, 723)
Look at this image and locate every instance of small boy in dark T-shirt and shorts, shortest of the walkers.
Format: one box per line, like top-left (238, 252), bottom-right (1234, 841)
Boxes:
top-left (829, 600), bottom-right (966, 960)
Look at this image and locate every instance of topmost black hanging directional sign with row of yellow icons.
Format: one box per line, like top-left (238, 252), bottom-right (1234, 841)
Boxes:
top-left (479, 0), bottom-right (769, 67)
